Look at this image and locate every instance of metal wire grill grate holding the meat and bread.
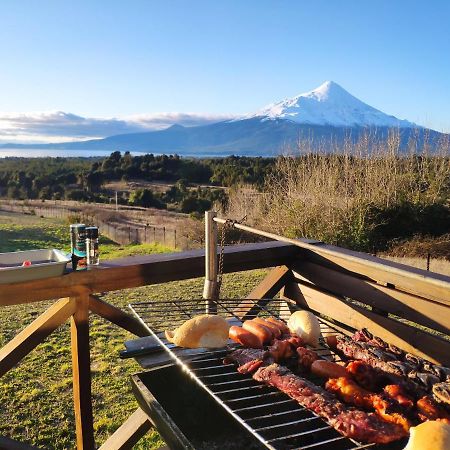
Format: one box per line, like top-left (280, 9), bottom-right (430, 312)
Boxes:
top-left (129, 299), bottom-right (387, 450)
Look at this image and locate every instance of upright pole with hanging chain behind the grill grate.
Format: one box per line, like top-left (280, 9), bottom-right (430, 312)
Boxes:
top-left (203, 211), bottom-right (218, 314)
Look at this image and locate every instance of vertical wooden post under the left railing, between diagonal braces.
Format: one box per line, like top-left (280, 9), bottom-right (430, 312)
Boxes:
top-left (70, 295), bottom-right (95, 450)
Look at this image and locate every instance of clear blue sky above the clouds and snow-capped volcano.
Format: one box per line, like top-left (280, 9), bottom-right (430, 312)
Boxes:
top-left (0, 0), bottom-right (450, 141)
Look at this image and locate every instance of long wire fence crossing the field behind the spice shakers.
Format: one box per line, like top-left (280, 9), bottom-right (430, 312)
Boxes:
top-left (0, 201), bottom-right (192, 250)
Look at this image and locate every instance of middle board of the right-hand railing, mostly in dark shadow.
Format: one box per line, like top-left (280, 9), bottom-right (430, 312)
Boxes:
top-left (292, 261), bottom-right (450, 334)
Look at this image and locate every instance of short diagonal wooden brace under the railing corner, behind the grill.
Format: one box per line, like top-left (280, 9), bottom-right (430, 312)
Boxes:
top-left (233, 266), bottom-right (292, 319)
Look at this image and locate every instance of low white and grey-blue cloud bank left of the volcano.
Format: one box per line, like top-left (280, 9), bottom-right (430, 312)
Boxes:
top-left (0, 111), bottom-right (235, 143)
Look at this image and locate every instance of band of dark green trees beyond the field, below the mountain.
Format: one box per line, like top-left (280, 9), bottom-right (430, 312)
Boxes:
top-left (0, 151), bottom-right (275, 213)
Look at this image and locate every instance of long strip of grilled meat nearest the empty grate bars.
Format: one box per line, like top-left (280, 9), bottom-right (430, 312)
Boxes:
top-left (253, 364), bottom-right (407, 444)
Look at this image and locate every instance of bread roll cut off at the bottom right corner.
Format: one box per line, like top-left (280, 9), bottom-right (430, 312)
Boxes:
top-left (404, 420), bottom-right (450, 450)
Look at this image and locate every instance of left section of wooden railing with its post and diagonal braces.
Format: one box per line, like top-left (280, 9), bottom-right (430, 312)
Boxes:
top-left (0, 242), bottom-right (298, 449)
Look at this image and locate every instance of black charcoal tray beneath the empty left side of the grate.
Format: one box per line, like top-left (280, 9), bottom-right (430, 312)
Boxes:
top-left (131, 364), bottom-right (264, 450)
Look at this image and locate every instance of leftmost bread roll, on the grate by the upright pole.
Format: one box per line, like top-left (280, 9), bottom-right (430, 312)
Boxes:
top-left (165, 314), bottom-right (230, 348)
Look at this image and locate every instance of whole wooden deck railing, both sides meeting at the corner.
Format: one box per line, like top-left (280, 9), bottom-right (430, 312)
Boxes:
top-left (0, 240), bottom-right (450, 449)
